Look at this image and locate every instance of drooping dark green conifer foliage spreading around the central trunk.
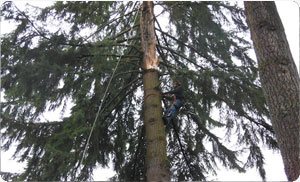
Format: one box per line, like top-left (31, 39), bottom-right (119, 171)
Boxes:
top-left (1, 1), bottom-right (277, 181)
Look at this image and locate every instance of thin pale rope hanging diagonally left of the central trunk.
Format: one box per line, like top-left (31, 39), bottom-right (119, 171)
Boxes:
top-left (78, 2), bottom-right (139, 173)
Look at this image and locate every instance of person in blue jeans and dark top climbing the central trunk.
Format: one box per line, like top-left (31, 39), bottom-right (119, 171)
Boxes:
top-left (163, 80), bottom-right (184, 124)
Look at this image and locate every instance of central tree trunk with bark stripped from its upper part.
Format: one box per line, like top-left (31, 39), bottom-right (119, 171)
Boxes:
top-left (140, 1), bottom-right (170, 181)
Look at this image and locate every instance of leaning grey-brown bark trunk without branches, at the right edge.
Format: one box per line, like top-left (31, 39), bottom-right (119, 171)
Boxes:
top-left (244, 1), bottom-right (300, 181)
